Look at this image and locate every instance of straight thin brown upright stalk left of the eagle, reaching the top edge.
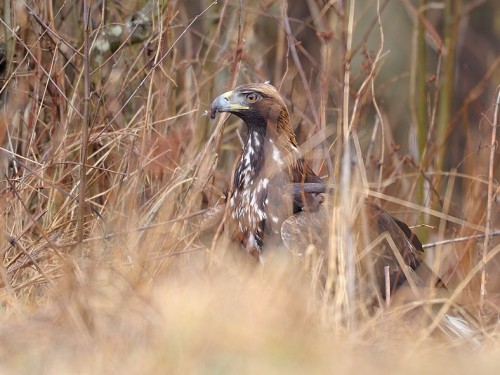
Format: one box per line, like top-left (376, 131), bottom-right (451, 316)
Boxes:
top-left (76, 0), bottom-right (91, 243)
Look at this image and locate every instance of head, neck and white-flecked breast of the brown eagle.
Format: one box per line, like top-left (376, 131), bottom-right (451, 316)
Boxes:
top-left (210, 84), bottom-right (321, 257)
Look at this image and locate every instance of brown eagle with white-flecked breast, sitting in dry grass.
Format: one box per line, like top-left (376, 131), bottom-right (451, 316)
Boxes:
top-left (210, 83), bottom-right (434, 294)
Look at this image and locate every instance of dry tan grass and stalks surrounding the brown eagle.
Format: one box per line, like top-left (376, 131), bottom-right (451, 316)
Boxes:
top-left (0, 0), bottom-right (500, 374)
